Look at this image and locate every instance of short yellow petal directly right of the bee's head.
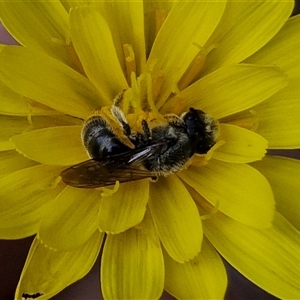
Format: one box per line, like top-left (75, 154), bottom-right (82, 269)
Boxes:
top-left (213, 124), bottom-right (268, 163)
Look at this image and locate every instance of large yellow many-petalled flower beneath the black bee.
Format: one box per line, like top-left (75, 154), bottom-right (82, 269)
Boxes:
top-left (0, 1), bottom-right (300, 299)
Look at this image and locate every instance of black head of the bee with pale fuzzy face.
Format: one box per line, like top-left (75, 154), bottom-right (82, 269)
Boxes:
top-left (182, 108), bottom-right (217, 154)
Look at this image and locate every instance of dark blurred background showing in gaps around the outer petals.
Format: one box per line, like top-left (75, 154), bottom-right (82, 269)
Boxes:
top-left (0, 0), bottom-right (300, 300)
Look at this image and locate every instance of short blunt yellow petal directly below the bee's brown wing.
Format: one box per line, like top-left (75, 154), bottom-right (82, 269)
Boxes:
top-left (99, 180), bottom-right (149, 233)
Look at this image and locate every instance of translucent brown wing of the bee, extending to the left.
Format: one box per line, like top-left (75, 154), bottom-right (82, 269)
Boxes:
top-left (60, 145), bottom-right (164, 188)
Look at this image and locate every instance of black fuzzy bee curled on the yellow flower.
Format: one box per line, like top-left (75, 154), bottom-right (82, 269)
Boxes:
top-left (61, 98), bottom-right (217, 188)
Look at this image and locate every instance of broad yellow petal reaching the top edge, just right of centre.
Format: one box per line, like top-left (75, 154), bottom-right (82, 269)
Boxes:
top-left (147, 1), bottom-right (226, 106)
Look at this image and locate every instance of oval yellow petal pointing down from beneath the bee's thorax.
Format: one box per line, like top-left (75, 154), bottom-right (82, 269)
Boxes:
top-left (149, 176), bottom-right (202, 262)
